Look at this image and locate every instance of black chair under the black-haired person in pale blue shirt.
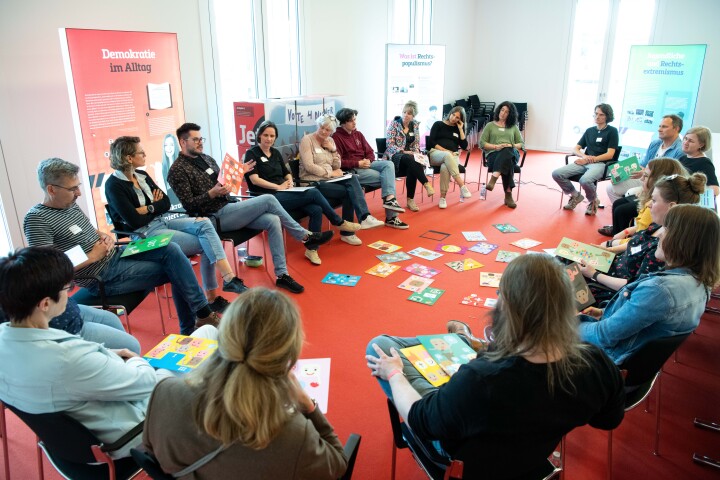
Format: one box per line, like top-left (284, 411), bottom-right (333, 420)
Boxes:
top-left (5, 404), bottom-right (143, 480)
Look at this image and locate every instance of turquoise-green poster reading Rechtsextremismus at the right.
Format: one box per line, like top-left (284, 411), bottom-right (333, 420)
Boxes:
top-left (615, 45), bottom-right (707, 165)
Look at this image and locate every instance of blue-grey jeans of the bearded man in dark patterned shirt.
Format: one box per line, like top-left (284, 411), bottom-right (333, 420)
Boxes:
top-left (215, 195), bottom-right (308, 277)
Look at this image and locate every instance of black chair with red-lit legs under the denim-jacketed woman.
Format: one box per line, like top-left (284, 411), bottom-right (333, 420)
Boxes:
top-left (608, 333), bottom-right (690, 479)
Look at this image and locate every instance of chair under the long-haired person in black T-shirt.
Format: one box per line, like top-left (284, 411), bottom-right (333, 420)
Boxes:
top-left (387, 399), bottom-right (565, 480)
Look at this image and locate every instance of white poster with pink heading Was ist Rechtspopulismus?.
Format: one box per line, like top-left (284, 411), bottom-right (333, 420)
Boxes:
top-left (385, 43), bottom-right (445, 148)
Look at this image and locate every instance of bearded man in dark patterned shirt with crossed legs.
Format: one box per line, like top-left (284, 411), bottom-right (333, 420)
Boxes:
top-left (167, 123), bottom-right (333, 293)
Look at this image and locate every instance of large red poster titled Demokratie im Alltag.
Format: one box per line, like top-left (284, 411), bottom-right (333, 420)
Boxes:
top-left (61, 29), bottom-right (185, 231)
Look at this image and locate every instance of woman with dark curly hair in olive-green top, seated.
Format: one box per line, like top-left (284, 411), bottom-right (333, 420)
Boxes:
top-left (480, 102), bottom-right (524, 208)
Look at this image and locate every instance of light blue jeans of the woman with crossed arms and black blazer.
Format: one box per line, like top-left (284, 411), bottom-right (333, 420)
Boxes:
top-left (136, 216), bottom-right (227, 290)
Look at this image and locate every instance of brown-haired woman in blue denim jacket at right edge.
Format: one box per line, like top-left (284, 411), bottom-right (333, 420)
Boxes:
top-left (580, 205), bottom-right (720, 364)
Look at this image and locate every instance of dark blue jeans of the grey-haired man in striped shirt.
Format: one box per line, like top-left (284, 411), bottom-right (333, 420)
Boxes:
top-left (96, 243), bottom-right (208, 335)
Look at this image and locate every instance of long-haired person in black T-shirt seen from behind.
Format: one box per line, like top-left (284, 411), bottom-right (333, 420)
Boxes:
top-left (365, 255), bottom-right (625, 478)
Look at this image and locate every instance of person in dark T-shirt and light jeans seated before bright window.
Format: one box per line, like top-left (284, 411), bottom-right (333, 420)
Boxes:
top-left (552, 103), bottom-right (619, 215)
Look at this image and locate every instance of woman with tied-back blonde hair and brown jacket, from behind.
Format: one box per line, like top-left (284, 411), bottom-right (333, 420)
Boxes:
top-left (143, 288), bottom-right (347, 480)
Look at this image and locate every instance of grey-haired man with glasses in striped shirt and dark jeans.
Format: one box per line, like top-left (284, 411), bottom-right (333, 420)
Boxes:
top-left (24, 158), bottom-right (219, 335)
